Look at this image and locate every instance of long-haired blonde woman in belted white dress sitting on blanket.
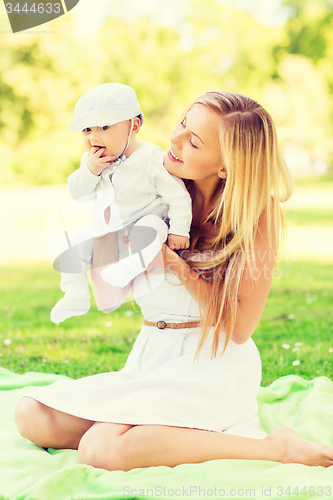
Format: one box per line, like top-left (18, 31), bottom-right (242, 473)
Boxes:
top-left (15, 92), bottom-right (333, 471)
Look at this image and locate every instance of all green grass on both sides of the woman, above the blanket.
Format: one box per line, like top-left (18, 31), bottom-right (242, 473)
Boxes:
top-left (0, 263), bottom-right (333, 386)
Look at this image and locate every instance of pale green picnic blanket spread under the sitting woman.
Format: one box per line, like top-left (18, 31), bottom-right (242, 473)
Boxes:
top-left (0, 368), bottom-right (333, 500)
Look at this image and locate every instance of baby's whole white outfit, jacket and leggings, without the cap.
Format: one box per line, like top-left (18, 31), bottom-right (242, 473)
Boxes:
top-left (51, 142), bottom-right (192, 323)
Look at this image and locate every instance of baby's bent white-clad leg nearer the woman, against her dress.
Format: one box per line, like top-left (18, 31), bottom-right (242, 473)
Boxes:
top-left (102, 214), bottom-right (168, 287)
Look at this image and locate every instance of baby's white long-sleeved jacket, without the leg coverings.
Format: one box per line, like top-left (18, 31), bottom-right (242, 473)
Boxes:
top-left (68, 142), bottom-right (192, 237)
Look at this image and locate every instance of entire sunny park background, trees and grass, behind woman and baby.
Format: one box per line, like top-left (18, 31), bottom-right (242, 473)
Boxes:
top-left (0, 0), bottom-right (333, 385)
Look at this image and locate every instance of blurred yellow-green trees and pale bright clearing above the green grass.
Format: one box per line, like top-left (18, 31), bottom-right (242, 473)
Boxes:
top-left (0, 0), bottom-right (333, 260)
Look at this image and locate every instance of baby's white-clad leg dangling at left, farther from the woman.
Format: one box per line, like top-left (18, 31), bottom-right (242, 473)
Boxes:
top-left (51, 235), bottom-right (93, 323)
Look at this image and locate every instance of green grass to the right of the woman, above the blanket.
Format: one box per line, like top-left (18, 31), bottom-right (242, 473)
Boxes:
top-left (253, 262), bottom-right (333, 385)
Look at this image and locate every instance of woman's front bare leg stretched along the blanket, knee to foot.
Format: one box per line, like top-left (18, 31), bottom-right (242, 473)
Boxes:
top-left (79, 423), bottom-right (333, 471)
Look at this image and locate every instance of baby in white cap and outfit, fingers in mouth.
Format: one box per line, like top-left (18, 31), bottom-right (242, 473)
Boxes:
top-left (51, 83), bottom-right (192, 323)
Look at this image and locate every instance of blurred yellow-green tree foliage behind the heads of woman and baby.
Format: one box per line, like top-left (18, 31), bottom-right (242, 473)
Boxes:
top-left (0, 0), bottom-right (333, 186)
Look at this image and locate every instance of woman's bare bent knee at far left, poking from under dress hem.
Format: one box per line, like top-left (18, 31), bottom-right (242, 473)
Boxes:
top-left (14, 397), bottom-right (95, 450)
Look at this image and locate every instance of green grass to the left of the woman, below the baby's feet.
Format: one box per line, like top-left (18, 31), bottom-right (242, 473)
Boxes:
top-left (0, 264), bottom-right (141, 378)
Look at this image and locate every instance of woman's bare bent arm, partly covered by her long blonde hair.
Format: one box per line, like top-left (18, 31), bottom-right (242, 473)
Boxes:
top-left (163, 207), bottom-right (277, 344)
